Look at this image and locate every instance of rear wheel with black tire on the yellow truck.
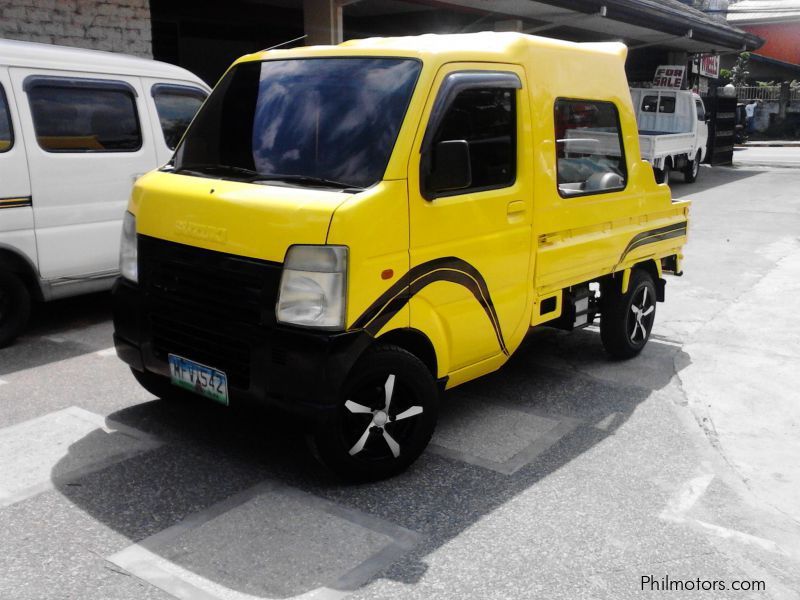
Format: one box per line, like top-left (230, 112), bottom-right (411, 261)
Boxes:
top-left (600, 269), bottom-right (656, 359)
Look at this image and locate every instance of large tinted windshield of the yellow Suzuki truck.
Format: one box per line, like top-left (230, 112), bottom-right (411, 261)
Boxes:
top-left (174, 58), bottom-right (420, 188)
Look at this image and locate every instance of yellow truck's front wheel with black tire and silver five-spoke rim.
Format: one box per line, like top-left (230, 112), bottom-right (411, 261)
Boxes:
top-left (309, 344), bottom-right (439, 481)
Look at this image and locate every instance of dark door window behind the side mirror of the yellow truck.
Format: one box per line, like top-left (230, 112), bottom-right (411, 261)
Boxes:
top-left (434, 88), bottom-right (517, 194)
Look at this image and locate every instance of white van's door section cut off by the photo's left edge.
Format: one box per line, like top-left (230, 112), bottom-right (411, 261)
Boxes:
top-left (0, 67), bottom-right (36, 266)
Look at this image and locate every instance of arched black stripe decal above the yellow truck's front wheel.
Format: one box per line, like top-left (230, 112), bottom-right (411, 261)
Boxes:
top-left (352, 256), bottom-right (509, 356)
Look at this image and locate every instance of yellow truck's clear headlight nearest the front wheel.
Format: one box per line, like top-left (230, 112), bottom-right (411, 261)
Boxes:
top-left (275, 246), bottom-right (347, 329)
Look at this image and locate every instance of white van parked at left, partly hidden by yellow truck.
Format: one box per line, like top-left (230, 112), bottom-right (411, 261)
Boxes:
top-left (0, 40), bottom-right (210, 347)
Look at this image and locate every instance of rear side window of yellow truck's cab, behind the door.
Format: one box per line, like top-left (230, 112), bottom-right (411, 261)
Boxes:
top-left (555, 100), bottom-right (627, 197)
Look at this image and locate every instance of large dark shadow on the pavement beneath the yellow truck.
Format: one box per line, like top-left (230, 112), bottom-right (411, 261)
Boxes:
top-left (52, 329), bottom-right (689, 598)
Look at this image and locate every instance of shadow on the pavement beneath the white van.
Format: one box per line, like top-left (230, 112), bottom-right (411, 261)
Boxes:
top-left (0, 292), bottom-right (112, 375)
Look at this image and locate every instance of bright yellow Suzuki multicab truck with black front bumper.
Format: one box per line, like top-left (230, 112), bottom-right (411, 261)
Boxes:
top-left (114, 33), bottom-right (689, 480)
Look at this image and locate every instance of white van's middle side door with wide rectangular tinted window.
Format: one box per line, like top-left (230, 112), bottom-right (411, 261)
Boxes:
top-left (11, 68), bottom-right (156, 284)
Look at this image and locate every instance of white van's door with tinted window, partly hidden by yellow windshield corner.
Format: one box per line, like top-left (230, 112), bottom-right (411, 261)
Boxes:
top-left (142, 77), bottom-right (208, 165)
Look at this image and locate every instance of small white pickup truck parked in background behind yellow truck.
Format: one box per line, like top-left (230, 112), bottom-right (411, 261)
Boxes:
top-left (631, 88), bottom-right (708, 183)
